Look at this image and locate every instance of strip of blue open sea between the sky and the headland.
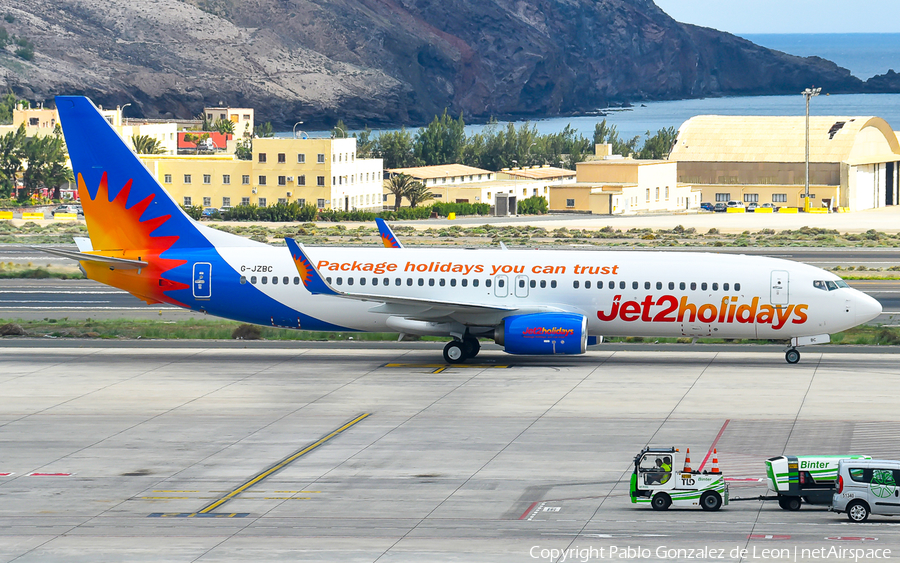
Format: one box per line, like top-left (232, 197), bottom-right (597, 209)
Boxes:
top-left (741, 33), bottom-right (900, 80)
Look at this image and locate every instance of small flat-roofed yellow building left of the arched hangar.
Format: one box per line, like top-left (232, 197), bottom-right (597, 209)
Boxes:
top-left (550, 156), bottom-right (700, 215)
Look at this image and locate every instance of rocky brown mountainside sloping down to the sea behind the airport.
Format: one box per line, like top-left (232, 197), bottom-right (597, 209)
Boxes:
top-left (0, 0), bottom-right (884, 128)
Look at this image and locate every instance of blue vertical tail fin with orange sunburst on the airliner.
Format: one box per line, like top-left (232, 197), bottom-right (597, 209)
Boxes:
top-left (56, 96), bottom-right (212, 253)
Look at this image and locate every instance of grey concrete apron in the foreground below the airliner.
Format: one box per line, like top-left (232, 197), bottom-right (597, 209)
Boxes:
top-left (0, 341), bottom-right (900, 563)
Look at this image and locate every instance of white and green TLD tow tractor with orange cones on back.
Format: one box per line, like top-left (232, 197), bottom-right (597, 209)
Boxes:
top-left (630, 447), bottom-right (728, 510)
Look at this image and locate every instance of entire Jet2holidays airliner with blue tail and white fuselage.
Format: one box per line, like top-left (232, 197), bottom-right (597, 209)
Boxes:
top-left (49, 96), bottom-right (881, 363)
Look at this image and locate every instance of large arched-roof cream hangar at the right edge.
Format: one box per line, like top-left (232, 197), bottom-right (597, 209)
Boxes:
top-left (669, 115), bottom-right (900, 210)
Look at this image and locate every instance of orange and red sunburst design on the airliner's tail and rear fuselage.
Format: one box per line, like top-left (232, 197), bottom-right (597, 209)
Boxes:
top-left (78, 172), bottom-right (190, 306)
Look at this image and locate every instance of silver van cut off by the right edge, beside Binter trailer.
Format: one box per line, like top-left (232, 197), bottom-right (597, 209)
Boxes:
top-left (831, 459), bottom-right (900, 522)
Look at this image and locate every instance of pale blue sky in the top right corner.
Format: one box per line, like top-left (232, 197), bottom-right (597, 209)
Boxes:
top-left (654, 0), bottom-right (900, 35)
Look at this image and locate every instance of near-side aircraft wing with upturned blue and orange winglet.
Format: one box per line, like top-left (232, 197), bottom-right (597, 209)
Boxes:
top-left (284, 237), bottom-right (524, 319)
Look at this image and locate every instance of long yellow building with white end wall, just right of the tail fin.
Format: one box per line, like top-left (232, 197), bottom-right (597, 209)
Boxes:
top-left (141, 138), bottom-right (382, 211)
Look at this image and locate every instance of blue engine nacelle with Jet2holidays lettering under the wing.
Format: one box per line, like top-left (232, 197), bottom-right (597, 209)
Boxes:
top-left (494, 313), bottom-right (587, 354)
